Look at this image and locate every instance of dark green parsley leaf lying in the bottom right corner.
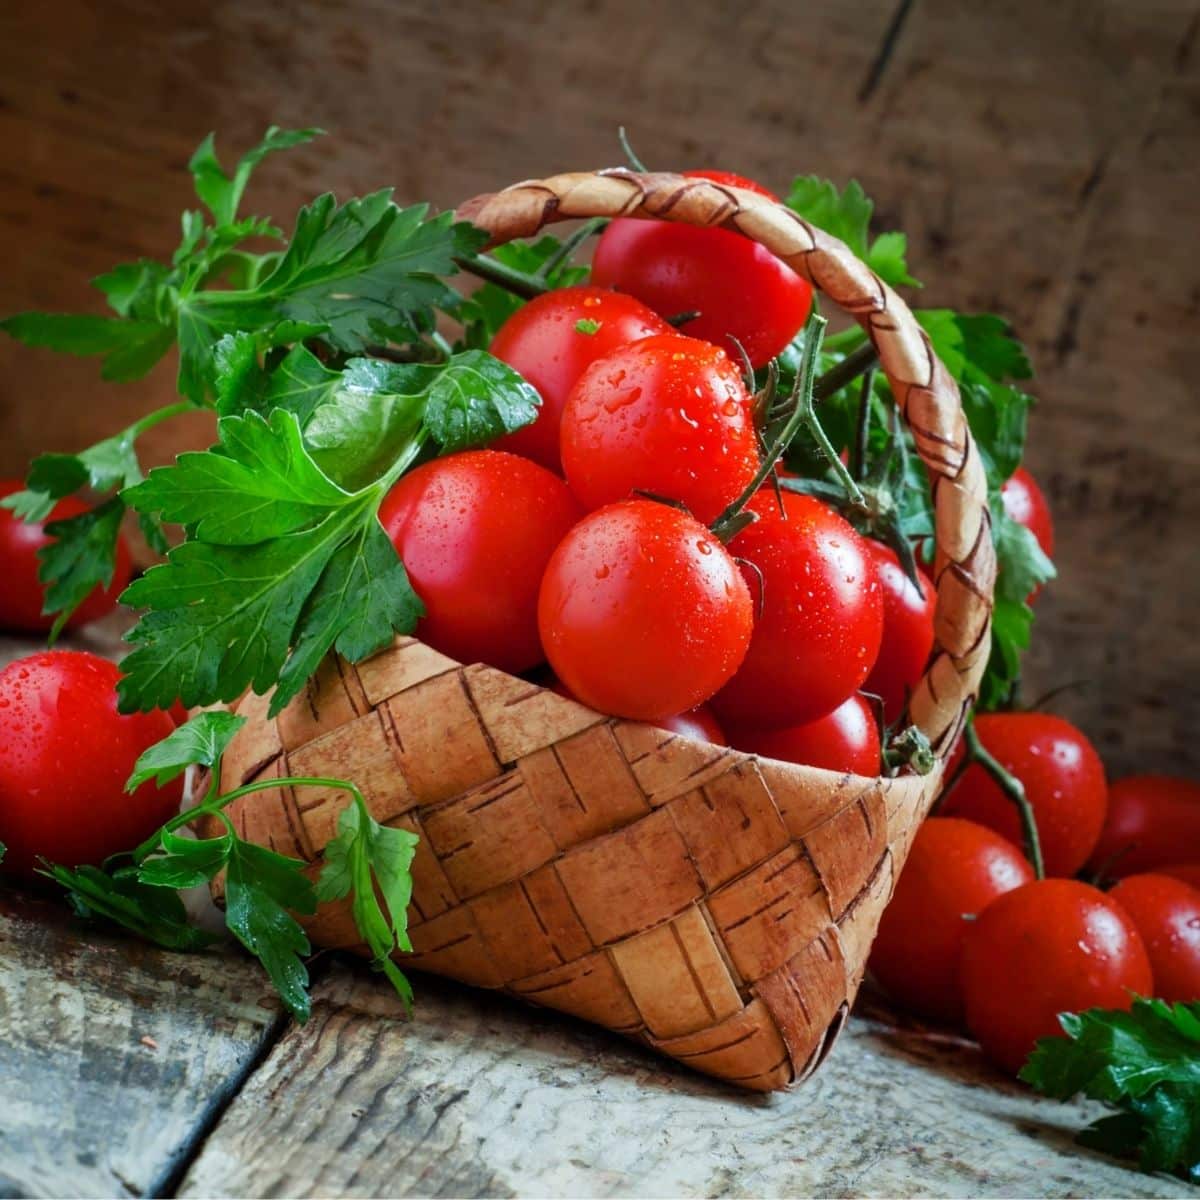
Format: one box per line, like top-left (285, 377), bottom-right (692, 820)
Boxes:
top-left (1021, 998), bottom-right (1200, 1183)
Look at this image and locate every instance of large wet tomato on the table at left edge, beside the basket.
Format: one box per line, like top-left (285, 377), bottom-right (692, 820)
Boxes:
top-left (0, 650), bottom-right (184, 875)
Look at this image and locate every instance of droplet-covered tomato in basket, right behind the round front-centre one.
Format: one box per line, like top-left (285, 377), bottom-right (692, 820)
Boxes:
top-left (713, 492), bottom-right (883, 730)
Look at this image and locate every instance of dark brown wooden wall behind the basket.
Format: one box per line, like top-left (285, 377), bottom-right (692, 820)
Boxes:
top-left (0, 0), bottom-right (1200, 772)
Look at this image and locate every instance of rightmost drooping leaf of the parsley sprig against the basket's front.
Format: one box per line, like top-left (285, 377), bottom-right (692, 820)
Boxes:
top-left (317, 792), bottom-right (418, 1008)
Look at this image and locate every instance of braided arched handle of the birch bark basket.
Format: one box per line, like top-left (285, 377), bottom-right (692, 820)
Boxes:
top-left (456, 169), bottom-right (996, 758)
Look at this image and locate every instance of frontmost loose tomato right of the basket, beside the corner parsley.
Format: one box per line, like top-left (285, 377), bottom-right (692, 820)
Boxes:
top-left (960, 880), bottom-right (1153, 1074)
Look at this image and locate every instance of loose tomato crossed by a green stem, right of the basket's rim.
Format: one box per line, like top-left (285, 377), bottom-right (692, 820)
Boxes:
top-left (942, 713), bottom-right (1108, 875)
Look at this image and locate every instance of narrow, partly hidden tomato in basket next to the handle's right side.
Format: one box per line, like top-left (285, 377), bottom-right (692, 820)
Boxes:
top-left (864, 539), bottom-right (937, 722)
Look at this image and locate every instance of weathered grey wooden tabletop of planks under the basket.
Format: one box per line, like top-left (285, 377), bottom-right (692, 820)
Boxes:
top-left (0, 633), bottom-right (1194, 1196)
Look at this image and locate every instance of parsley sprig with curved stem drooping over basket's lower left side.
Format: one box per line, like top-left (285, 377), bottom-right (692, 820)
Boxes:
top-left (42, 712), bottom-right (418, 1021)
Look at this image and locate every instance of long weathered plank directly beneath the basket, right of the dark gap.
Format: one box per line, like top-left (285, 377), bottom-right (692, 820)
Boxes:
top-left (180, 965), bottom-right (1190, 1196)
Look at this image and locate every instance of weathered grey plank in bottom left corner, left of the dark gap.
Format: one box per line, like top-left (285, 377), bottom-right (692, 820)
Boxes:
top-left (0, 888), bottom-right (281, 1196)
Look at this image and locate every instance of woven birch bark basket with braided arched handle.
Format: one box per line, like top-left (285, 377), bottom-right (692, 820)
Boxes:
top-left (204, 170), bottom-right (996, 1091)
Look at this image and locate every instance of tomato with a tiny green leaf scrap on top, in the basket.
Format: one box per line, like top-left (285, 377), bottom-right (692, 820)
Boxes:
top-left (490, 288), bottom-right (671, 474)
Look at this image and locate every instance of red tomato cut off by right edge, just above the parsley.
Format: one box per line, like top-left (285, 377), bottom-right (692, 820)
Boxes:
top-left (1109, 875), bottom-right (1200, 1003)
